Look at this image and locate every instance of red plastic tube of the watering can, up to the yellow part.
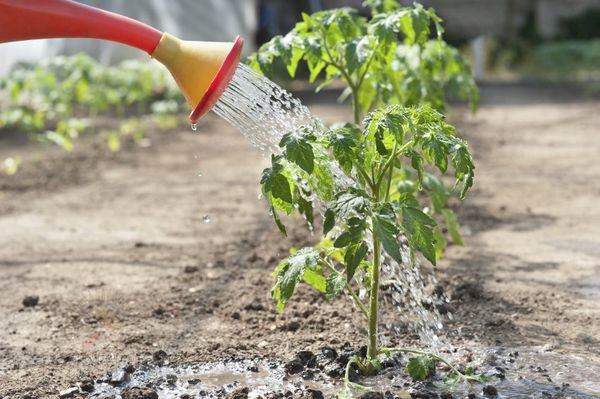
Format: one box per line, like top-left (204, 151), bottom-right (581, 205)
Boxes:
top-left (0, 0), bottom-right (162, 54)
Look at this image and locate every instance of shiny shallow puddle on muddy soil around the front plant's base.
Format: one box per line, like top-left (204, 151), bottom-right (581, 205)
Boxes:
top-left (90, 348), bottom-right (600, 399)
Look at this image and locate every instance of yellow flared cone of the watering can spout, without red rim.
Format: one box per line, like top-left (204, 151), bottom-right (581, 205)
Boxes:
top-left (151, 33), bottom-right (232, 109)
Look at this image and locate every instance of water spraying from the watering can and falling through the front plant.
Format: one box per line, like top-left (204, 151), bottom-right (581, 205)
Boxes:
top-left (213, 64), bottom-right (449, 352)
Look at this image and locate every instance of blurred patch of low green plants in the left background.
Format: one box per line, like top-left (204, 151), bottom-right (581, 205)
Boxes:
top-left (0, 54), bottom-right (183, 170)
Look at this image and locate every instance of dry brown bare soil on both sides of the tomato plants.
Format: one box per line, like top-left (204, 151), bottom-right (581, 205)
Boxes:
top-left (0, 86), bottom-right (600, 398)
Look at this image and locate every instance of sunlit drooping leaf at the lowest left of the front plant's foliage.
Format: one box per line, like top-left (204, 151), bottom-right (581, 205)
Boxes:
top-left (272, 247), bottom-right (321, 312)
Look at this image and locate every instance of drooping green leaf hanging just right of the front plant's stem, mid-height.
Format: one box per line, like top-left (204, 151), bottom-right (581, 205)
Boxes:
top-left (402, 207), bottom-right (436, 265)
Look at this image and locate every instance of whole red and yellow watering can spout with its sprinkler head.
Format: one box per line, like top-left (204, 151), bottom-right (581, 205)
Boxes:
top-left (0, 0), bottom-right (244, 123)
